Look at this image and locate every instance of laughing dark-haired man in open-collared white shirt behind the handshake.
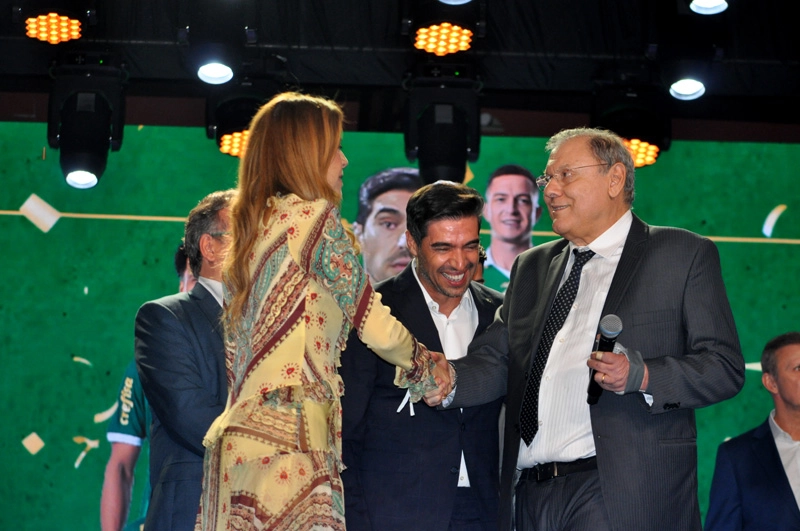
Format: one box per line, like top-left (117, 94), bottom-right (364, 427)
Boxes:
top-left (340, 181), bottom-right (502, 531)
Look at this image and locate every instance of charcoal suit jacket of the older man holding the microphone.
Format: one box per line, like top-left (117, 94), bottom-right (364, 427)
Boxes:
top-left (451, 215), bottom-right (744, 531)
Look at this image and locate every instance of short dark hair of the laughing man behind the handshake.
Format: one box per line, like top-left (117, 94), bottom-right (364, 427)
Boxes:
top-left (406, 181), bottom-right (483, 245)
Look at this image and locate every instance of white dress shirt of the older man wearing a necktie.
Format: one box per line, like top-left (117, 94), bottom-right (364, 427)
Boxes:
top-left (517, 210), bottom-right (633, 468)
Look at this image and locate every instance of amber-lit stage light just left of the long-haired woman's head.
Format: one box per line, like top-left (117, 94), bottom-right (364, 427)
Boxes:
top-left (206, 96), bottom-right (266, 157)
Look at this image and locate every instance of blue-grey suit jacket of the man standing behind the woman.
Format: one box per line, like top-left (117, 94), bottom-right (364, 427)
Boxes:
top-left (135, 283), bottom-right (228, 531)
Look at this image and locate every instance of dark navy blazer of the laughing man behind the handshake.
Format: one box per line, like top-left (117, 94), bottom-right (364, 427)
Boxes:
top-left (340, 265), bottom-right (502, 531)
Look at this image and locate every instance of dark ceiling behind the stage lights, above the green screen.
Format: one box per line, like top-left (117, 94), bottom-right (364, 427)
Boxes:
top-left (0, 0), bottom-right (800, 142)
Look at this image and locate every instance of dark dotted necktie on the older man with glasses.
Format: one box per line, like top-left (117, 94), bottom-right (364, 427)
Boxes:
top-left (520, 249), bottom-right (594, 445)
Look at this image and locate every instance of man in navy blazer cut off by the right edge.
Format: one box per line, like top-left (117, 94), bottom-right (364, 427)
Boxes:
top-left (706, 332), bottom-right (800, 531)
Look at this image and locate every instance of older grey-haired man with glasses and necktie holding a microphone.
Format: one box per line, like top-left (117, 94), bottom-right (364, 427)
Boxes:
top-left (428, 128), bottom-right (744, 531)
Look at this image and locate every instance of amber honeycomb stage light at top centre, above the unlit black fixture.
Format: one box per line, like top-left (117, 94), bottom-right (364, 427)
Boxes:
top-left (402, 0), bottom-right (486, 57)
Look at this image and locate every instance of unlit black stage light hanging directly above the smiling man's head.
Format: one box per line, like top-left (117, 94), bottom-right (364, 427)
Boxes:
top-left (404, 65), bottom-right (480, 183)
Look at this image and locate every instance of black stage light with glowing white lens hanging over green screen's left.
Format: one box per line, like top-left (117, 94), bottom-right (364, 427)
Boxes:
top-left (47, 53), bottom-right (126, 188)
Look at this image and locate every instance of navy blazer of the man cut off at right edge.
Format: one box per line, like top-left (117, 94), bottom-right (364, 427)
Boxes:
top-left (706, 419), bottom-right (800, 531)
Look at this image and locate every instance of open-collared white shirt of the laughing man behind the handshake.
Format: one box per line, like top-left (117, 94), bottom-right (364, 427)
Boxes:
top-left (410, 258), bottom-right (478, 487)
